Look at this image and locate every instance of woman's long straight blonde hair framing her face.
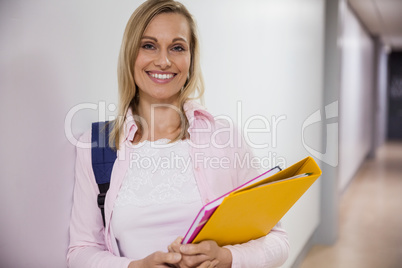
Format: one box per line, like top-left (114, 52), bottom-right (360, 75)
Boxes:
top-left (109, 0), bottom-right (204, 149)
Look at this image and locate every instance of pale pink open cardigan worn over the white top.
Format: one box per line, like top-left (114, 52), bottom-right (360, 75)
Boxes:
top-left (67, 101), bottom-right (289, 268)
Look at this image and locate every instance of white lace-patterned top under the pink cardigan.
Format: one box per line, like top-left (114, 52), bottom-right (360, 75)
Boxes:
top-left (111, 139), bottom-right (202, 259)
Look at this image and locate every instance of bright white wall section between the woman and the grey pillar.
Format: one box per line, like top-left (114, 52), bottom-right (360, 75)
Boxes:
top-left (185, 0), bottom-right (324, 267)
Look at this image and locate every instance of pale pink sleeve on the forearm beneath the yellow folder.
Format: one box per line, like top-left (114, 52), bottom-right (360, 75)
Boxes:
top-left (225, 222), bottom-right (289, 268)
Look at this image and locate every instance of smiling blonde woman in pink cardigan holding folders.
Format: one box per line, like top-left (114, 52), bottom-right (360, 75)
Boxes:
top-left (68, 0), bottom-right (289, 268)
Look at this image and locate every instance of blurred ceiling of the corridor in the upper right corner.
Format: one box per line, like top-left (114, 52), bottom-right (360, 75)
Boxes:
top-left (348, 0), bottom-right (402, 50)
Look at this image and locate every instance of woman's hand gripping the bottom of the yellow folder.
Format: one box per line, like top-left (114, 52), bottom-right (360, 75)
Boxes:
top-left (168, 237), bottom-right (232, 268)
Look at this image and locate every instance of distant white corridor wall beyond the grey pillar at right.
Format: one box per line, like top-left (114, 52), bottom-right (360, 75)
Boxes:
top-left (339, 1), bottom-right (375, 191)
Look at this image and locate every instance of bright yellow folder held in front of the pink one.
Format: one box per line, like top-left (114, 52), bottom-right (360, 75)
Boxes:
top-left (192, 157), bottom-right (321, 246)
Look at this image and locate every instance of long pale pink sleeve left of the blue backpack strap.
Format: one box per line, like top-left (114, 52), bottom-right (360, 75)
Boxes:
top-left (67, 131), bottom-right (131, 268)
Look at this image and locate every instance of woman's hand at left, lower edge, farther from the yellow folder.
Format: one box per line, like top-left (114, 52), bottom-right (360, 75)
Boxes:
top-left (128, 251), bottom-right (181, 268)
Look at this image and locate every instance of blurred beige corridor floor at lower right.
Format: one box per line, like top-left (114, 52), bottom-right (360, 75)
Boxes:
top-left (300, 142), bottom-right (402, 268)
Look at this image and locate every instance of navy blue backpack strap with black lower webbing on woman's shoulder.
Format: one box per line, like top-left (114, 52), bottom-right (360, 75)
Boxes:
top-left (91, 121), bottom-right (117, 225)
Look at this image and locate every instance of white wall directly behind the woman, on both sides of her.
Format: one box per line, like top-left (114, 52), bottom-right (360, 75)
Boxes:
top-left (0, 0), bottom-right (324, 268)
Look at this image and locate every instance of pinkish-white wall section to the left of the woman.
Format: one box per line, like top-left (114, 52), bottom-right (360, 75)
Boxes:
top-left (0, 0), bottom-right (129, 268)
